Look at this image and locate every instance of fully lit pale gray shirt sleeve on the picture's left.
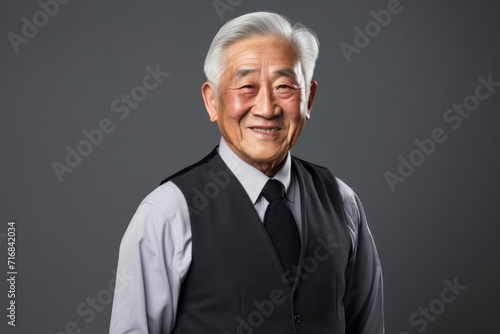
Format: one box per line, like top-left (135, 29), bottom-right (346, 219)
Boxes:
top-left (109, 182), bottom-right (191, 334)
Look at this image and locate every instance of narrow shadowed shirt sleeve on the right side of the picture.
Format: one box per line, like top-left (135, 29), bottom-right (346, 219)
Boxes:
top-left (339, 180), bottom-right (384, 334)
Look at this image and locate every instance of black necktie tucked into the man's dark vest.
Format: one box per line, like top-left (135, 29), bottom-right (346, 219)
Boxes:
top-left (262, 180), bottom-right (300, 275)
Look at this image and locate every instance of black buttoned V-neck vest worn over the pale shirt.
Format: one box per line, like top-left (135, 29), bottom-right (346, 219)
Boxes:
top-left (162, 150), bottom-right (351, 334)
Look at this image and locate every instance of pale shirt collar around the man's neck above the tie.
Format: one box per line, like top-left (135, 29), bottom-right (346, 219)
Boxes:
top-left (219, 138), bottom-right (295, 204)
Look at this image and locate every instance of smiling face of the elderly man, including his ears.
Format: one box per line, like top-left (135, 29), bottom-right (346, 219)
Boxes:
top-left (202, 37), bottom-right (316, 176)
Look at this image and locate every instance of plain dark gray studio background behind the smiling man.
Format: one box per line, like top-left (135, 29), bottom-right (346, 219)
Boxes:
top-left (0, 0), bottom-right (500, 334)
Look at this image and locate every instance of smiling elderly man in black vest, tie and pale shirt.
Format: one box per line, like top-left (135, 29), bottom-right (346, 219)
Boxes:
top-left (110, 12), bottom-right (384, 334)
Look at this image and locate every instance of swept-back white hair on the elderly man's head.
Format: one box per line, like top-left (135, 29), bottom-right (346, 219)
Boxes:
top-left (203, 12), bottom-right (319, 99)
